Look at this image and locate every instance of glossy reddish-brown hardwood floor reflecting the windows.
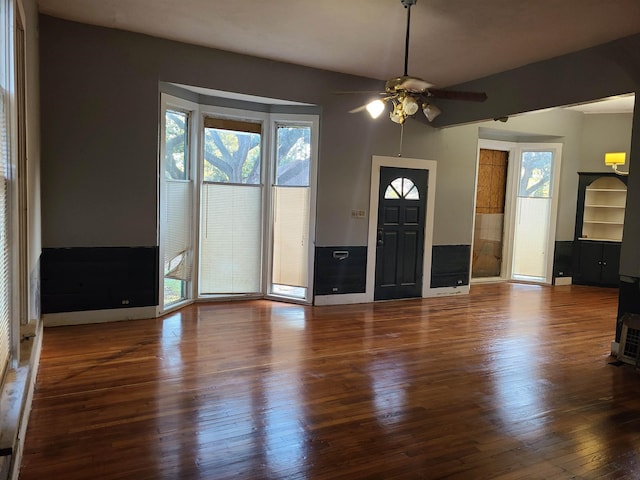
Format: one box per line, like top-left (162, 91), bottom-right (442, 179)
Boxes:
top-left (20, 284), bottom-right (640, 480)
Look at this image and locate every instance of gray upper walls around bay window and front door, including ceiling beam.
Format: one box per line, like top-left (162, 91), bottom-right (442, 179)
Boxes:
top-left (41, 16), bottom-right (640, 274)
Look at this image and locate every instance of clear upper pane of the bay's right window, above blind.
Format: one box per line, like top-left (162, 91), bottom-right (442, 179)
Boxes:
top-left (276, 125), bottom-right (311, 187)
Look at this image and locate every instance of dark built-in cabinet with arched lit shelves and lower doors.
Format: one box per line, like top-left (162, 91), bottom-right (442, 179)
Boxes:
top-left (573, 173), bottom-right (627, 287)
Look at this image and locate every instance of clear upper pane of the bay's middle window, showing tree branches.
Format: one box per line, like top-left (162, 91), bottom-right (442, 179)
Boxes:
top-left (204, 128), bottom-right (260, 185)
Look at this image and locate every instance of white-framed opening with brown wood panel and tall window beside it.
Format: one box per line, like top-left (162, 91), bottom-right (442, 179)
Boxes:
top-left (471, 140), bottom-right (562, 284)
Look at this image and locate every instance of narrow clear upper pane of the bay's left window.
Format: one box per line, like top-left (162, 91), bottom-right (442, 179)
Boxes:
top-left (165, 110), bottom-right (189, 180)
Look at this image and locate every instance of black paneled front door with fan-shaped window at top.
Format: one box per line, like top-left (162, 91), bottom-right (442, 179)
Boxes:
top-left (374, 167), bottom-right (428, 300)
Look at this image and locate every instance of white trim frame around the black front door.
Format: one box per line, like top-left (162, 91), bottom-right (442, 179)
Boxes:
top-left (365, 155), bottom-right (438, 302)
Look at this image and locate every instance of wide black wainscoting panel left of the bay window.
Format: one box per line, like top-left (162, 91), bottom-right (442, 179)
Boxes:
top-left (40, 246), bottom-right (159, 313)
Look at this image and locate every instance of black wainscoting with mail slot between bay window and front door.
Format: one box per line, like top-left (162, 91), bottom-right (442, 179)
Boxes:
top-left (314, 247), bottom-right (367, 295)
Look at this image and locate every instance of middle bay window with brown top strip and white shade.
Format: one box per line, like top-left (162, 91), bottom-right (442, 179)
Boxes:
top-left (199, 117), bottom-right (263, 295)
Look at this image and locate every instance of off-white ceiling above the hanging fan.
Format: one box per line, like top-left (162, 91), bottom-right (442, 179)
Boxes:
top-left (38, 0), bottom-right (640, 87)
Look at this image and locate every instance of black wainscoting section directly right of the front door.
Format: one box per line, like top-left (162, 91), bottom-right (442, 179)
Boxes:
top-left (431, 245), bottom-right (471, 288)
